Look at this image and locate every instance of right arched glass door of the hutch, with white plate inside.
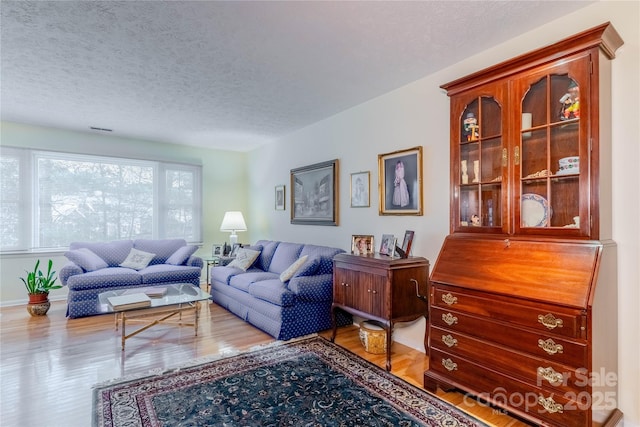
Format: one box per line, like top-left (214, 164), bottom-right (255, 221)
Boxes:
top-left (512, 53), bottom-right (590, 235)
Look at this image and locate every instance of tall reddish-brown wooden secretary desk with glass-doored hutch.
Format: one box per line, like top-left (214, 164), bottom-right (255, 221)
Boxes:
top-left (424, 23), bottom-right (623, 427)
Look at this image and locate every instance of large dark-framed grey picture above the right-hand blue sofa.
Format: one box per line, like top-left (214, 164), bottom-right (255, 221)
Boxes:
top-left (291, 159), bottom-right (338, 225)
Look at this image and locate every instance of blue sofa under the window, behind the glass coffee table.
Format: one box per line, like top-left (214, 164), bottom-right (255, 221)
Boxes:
top-left (59, 239), bottom-right (204, 318)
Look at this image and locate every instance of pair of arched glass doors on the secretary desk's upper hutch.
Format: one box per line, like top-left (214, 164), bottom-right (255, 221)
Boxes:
top-left (442, 33), bottom-right (599, 238)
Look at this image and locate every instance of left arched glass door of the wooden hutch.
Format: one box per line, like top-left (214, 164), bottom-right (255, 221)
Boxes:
top-left (452, 90), bottom-right (506, 233)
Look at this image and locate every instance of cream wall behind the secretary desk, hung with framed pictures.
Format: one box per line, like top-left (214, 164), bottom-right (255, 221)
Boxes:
top-left (248, 1), bottom-right (640, 426)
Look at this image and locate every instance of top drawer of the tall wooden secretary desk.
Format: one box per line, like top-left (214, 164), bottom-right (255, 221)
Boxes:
top-left (432, 286), bottom-right (586, 338)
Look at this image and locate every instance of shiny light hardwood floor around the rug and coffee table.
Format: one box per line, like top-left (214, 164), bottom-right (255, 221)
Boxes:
top-left (0, 301), bottom-right (526, 427)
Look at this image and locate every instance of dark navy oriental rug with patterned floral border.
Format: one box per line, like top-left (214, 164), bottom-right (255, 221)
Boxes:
top-left (92, 336), bottom-right (486, 427)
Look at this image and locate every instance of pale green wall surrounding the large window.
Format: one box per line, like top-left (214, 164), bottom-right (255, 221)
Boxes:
top-left (0, 122), bottom-right (248, 305)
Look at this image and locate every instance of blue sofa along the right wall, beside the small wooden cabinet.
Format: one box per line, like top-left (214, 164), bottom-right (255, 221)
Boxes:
top-left (210, 240), bottom-right (351, 340)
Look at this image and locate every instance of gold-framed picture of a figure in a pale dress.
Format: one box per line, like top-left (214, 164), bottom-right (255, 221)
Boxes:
top-left (378, 147), bottom-right (422, 215)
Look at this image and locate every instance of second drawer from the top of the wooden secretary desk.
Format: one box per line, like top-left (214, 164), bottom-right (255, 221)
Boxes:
top-left (429, 308), bottom-right (588, 367)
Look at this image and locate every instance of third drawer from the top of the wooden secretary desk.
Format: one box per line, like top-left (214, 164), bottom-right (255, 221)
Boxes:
top-left (429, 326), bottom-right (589, 394)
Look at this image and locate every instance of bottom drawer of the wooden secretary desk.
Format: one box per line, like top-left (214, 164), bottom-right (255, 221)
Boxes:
top-left (425, 348), bottom-right (591, 427)
